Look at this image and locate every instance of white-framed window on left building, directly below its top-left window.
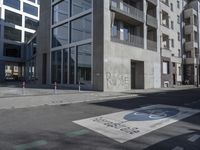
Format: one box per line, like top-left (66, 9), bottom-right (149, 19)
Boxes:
top-left (5, 10), bottom-right (22, 26)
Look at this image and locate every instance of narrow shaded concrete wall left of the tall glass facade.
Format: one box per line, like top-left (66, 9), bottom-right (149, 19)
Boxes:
top-left (36, 0), bottom-right (51, 84)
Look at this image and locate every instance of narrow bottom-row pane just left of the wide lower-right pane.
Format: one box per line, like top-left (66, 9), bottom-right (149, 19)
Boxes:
top-left (69, 47), bottom-right (76, 84)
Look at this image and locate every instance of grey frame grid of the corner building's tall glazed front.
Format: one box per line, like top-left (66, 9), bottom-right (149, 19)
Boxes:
top-left (50, 0), bottom-right (93, 85)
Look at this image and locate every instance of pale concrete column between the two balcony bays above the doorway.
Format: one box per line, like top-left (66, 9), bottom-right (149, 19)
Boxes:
top-left (143, 0), bottom-right (148, 49)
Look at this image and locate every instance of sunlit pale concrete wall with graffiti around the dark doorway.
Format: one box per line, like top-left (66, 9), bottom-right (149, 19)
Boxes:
top-left (101, 0), bottom-right (161, 91)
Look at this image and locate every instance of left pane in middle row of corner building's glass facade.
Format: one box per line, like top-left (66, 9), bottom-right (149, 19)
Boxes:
top-left (52, 23), bottom-right (69, 47)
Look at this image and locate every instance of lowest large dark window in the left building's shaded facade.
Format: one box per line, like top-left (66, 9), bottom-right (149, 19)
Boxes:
top-left (4, 43), bottom-right (21, 58)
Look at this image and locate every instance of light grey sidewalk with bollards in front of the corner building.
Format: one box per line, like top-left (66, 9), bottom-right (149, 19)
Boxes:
top-left (0, 87), bottom-right (197, 109)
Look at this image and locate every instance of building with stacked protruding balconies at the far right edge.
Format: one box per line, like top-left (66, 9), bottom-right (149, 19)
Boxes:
top-left (183, 0), bottom-right (200, 85)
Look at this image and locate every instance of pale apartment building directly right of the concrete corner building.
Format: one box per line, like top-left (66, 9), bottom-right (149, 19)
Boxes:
top-left (160, 0), bottom-right (186, 87)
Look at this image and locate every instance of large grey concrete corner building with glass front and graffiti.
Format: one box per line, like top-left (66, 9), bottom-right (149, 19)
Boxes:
top-left (36, 0), bottom-right (161, 91)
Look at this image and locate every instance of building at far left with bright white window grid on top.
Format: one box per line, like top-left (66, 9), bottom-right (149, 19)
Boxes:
top-left (0, 0), bottom-right (40, 81)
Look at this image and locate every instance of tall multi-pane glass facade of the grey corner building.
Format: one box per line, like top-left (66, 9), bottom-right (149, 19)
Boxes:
top-left (51, 0), bottom-right (92, 85)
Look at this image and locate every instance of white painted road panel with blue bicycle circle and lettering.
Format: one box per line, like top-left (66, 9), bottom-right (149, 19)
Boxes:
top-left (73, 105), bottom-right (200, 143)
